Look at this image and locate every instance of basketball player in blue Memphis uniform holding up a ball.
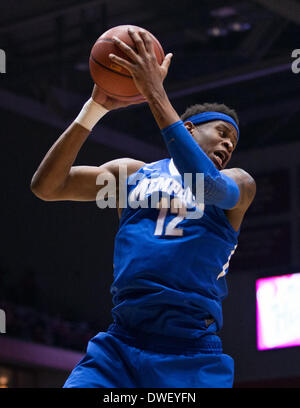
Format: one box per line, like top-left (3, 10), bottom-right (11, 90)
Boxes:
top-left (31, 27), bottom-right (256, 388)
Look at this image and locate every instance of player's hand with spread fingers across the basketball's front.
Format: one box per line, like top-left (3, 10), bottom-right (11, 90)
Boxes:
top-left (109, 29), bottom-right (173, 99)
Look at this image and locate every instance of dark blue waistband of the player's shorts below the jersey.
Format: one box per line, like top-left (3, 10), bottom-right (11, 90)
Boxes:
top-left (107, 323), bottom-right (223, 354)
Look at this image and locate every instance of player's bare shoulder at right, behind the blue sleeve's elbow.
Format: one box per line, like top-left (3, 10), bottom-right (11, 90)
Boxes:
top-left (222, 168), bottom-right (256, 212)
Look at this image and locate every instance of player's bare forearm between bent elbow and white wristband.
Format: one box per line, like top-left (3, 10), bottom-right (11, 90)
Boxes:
top-left (31, 122), bottom-right (90, 198)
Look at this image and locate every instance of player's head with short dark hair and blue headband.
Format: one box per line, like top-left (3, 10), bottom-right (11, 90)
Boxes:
top-left (181, 103), bottom-right (239, 170)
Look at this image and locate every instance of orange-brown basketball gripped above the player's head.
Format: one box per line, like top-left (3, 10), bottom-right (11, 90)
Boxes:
top-left (89, 25), bottom-right (165, 101)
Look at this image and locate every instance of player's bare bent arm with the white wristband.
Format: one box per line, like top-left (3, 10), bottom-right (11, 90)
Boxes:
top-left (31, 86), bottom-right (144, 201)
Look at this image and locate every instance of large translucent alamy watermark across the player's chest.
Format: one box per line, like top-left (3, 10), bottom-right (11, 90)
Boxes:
top-left (96, 165), bottom-right (204, 219)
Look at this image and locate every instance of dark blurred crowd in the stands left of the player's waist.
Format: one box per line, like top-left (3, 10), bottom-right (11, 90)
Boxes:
top-left (0, 300), bottom-right (99, 353)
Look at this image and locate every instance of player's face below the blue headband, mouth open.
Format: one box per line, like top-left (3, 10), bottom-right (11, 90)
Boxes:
top-left (185, 120), bottom-right (237, 170)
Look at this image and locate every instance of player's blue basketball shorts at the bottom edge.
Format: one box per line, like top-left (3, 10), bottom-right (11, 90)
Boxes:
top-left (63, 329), bottom-right (234, 388)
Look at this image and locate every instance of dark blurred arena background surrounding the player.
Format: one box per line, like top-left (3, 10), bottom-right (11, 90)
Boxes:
top-left (0, 0), bottom-right (300, 388)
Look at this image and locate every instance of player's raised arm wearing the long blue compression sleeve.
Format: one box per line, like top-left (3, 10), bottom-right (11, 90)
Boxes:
top-left (110, 31), bottom-right (240, 209)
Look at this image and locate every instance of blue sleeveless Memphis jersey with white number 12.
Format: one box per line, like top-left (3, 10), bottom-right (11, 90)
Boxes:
top-left (111, 159), bottom-right (238, 339)
